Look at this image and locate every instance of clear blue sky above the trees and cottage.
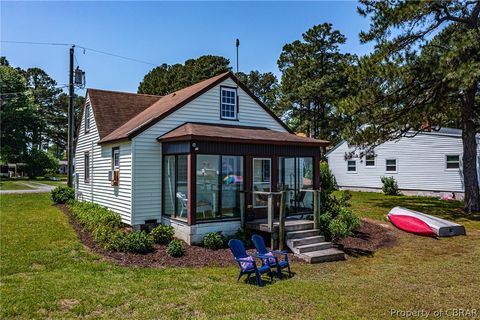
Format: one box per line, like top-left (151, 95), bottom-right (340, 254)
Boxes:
top-left (0, 1), bottom-right (373, 94)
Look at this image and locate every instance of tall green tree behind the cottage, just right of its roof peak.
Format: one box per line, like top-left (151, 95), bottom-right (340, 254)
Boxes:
top-left (278, 23), bottom-right (356, 143)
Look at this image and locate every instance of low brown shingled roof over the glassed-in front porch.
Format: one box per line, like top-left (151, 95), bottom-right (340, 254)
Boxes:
top-left (157, 123), bottom-right (330, 147)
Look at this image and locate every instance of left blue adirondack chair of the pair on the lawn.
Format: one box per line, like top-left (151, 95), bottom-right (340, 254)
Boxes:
top-left (228, 239), bottom-right (272, 287)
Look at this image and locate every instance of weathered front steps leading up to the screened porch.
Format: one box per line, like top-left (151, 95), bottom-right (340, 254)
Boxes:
top-left (285, 220), bottom-right (345, 263)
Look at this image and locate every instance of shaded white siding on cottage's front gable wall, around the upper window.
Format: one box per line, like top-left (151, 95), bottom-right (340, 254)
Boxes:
top-left (131, 79), bottom-right (286, 225)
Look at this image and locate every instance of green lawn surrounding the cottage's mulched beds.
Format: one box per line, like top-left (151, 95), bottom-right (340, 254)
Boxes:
top-left (0, 193), bottom-right (480, 319)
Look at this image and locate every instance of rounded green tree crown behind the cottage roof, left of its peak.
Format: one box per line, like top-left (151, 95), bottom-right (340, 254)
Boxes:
top-left (138, 55), bottom-right (230, 95)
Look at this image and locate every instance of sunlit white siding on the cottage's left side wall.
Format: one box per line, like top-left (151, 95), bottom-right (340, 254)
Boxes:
top-left (75, 97), bottom-right (132, 224)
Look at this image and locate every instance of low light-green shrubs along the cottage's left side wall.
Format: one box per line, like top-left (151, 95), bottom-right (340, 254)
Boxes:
top-left (69, 201), bottom-right (122, 232)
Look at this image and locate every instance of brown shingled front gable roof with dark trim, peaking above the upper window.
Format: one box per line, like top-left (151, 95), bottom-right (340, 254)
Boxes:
top-left (90, 72), bottom-right (292, 144)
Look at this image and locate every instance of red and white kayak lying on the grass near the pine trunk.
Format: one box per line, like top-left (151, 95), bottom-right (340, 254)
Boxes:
top-left (387, 207), bottom-right (465, 237)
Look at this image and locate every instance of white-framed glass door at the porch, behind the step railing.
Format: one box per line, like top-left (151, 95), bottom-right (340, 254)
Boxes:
top-left (252, 158), bottom-right (272, 208)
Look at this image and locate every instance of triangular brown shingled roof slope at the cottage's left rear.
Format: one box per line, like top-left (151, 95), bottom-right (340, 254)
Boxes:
top-left (87, 89), bottom-right (162, 139)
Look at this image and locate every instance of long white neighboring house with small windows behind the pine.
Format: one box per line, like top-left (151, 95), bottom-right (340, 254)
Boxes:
top-left (326, 128), bottom-right (480, 198)
